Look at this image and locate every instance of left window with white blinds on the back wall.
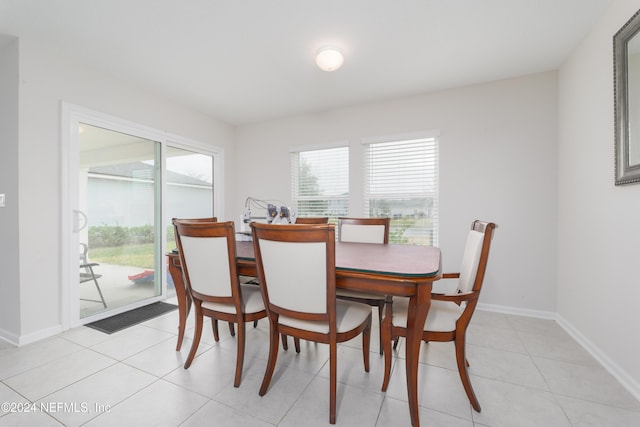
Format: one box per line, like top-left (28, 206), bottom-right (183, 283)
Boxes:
top-left (291, 147), bottom-right (349, 218)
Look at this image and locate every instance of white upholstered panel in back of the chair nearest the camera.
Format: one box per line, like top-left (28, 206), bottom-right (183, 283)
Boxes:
top-left (259, 240), bottom-right (327, 313)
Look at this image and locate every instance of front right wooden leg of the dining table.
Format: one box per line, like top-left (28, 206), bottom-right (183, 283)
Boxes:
top-left (405, 285), bottom-right (431, 427)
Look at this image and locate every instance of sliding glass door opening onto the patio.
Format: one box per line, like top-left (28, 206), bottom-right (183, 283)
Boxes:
top-left (61, 103), bottom-right (223, 329)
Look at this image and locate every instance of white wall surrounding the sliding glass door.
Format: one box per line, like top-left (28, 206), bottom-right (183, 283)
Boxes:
top-left (13, 39), bottom-right (234, 342)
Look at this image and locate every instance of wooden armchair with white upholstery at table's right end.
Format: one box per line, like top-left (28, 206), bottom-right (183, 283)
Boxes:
top-left (382, 221), bottom-right (496, 412)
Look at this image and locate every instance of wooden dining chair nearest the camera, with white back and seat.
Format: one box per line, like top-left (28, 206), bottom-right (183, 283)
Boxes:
top-left (251, 223), bottom-right (371, 424)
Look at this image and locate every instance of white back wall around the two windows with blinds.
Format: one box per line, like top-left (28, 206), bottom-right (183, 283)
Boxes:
top-left (236, 72), bottom-right (557, 316)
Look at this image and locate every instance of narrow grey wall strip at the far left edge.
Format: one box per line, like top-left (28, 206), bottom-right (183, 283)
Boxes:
top-left (0, 38), bottom-right (20, 341)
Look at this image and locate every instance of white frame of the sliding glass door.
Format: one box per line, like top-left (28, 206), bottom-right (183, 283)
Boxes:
top-left (59, 102), bottom-right (224, 330)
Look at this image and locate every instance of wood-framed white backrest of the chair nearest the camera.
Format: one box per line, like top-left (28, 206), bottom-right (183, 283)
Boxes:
top-left (251, 223), bottom-right (336, 323)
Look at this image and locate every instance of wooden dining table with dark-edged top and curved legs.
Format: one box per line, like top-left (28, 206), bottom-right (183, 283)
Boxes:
top-left (168, 238), bottom-right (441, 427)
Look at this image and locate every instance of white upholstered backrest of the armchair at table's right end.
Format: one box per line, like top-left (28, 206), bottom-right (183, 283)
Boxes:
top-left (458, 220), bottom-right (496, 292)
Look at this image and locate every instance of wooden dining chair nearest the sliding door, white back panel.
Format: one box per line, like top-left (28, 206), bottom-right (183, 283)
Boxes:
top-left (173, 220), bottom-right (267, 387)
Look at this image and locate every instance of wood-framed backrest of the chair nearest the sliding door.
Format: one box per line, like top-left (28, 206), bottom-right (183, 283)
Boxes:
top-left (173, 219), bottom-right (241, 303)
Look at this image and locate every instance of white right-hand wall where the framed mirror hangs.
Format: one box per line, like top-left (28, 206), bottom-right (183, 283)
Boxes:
top-left (558, 0), bottom-right (640, 396)
